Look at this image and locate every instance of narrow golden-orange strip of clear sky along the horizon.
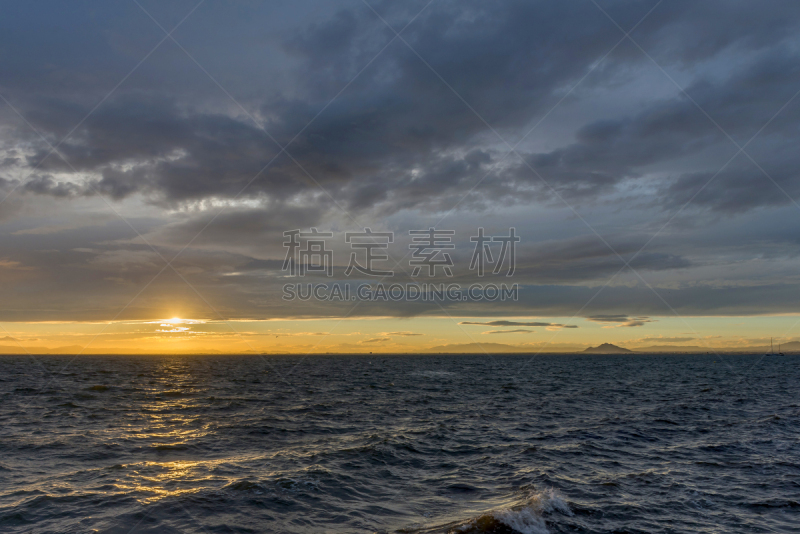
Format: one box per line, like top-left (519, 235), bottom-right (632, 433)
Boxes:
top-left (0, 315), bottom-right (800, 354)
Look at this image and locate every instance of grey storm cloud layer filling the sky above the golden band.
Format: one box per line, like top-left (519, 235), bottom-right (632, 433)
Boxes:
top-left (0, 0), bottom-right (800, 326)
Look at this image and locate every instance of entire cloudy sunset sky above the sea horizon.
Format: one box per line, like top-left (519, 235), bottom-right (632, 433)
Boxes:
top-left (0, 0), bottom-right (800, 354)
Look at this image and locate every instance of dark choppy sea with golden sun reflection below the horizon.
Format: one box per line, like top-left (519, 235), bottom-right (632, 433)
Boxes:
top-left (0, 355), bottom-right (800, 534)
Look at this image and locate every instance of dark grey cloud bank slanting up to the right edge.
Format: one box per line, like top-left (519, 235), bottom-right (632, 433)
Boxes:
top-left (530, 47), bottom-right (800, 211)
